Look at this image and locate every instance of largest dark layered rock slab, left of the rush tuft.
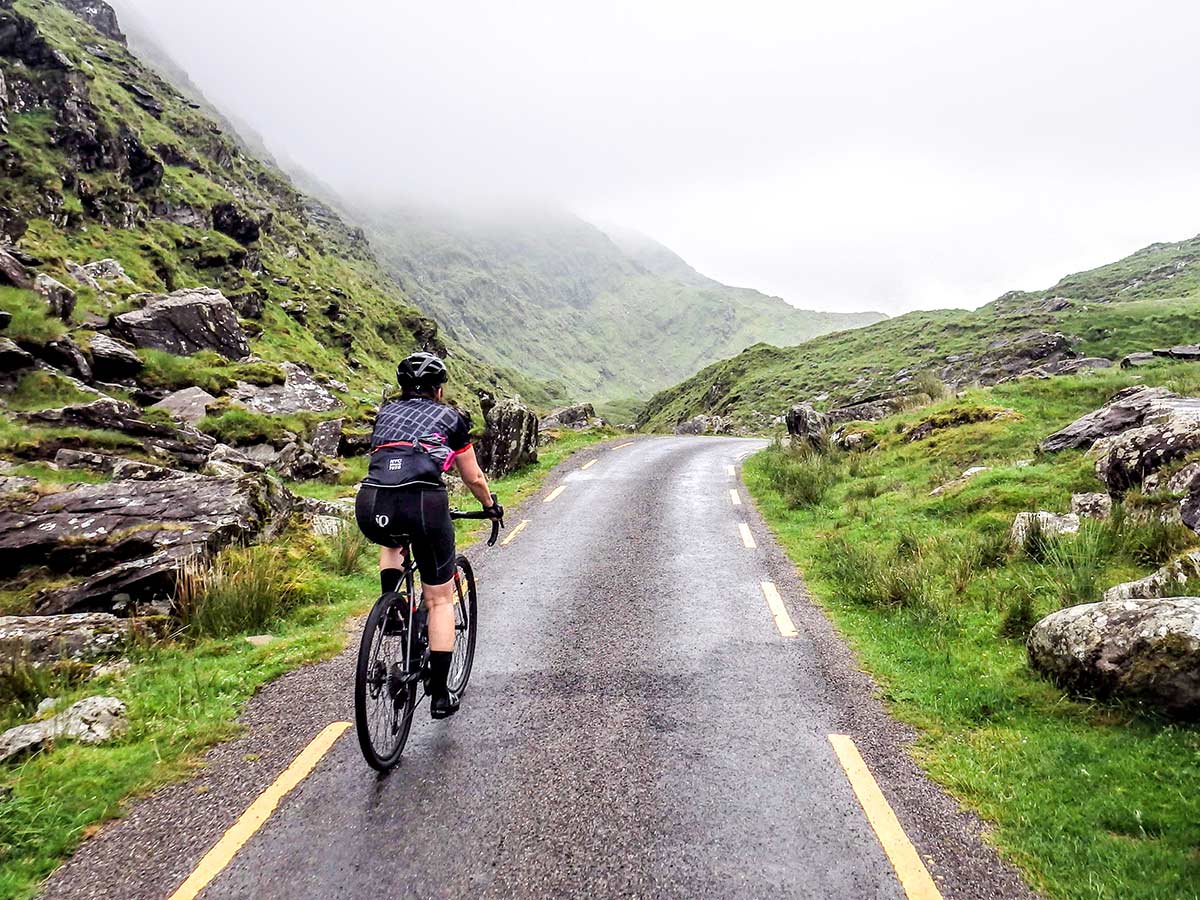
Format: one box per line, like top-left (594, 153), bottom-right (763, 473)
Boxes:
top-left (0, 475), bottom-right (294, 614)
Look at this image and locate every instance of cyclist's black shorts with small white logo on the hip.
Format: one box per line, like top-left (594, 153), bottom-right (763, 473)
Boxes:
top-left (354, 485), bottom-right (457, 584)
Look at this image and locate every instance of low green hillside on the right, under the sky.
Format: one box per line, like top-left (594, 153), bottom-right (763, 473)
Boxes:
top-left (640, 238), bottom-right (1200, 428)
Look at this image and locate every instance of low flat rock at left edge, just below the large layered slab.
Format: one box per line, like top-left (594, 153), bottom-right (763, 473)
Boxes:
top-left (0, 612), bottom-right (155, 665)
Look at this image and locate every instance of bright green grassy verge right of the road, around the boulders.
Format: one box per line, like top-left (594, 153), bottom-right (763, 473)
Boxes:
top-left (745, 366), bottom-right (1200, 900)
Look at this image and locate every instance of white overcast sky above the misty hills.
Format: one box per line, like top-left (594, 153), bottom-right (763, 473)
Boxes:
top-left (113, 0), bottom-right (1200, 313)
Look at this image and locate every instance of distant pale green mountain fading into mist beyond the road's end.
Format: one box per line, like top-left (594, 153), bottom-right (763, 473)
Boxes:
top-left (364, 209), bottom-right (881, 400)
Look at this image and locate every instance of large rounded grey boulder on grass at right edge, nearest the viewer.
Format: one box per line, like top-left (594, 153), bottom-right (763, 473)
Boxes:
top-left (1026, 596), bottom-right (1200, 720)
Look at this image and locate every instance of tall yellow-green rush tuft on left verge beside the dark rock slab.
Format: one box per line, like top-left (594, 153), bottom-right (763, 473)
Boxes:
top-left (175, 546), bottom-right (301, 638)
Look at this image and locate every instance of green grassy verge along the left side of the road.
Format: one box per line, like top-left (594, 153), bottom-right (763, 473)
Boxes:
top-left (0, 432), bottom-right (611, 898)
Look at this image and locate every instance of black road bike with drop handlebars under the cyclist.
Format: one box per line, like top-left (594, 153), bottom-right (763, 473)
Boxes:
top-left (354, 497), bottom-right (504, 772)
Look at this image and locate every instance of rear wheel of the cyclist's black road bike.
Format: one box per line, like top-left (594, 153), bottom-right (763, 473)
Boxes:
top-left (354, 594), bottom-right (418, 772)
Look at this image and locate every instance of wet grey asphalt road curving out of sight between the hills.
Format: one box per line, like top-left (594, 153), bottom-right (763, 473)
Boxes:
top-left (44, 438), bottom-right (1024, 900)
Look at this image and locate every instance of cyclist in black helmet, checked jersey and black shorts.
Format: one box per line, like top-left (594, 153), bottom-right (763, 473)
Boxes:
top-left (355, 353), bottom-right (504, 719)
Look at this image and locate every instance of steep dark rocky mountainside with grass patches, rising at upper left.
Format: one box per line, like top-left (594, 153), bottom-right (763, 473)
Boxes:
top-left (0, 0), bottom-right (552, 420)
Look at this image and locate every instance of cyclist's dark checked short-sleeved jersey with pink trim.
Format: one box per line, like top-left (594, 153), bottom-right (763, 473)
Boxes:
top-left (362, 397), bottom-right (470, 488)
